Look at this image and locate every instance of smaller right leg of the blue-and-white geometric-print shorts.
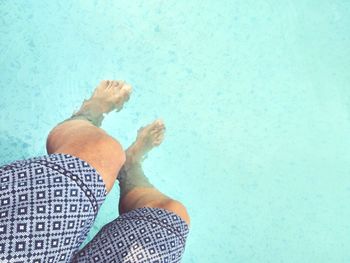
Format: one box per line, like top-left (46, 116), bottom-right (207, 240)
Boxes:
top-left (73, 207), bottom-right (189, 263)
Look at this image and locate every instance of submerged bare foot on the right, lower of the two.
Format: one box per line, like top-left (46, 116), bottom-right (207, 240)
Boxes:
top-left (125, 120), bottom-right (165, 169)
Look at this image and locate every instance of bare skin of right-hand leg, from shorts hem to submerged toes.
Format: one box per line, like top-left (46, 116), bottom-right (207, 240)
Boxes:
top-left (118, 120), bottom-right (190, 224)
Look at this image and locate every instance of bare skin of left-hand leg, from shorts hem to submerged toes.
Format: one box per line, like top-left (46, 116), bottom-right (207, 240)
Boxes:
top-left (46, 80), bottom-right (131, 191)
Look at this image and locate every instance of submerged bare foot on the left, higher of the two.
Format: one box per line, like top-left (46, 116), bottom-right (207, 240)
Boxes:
top-left (81, 80), bottom-right (132, 113)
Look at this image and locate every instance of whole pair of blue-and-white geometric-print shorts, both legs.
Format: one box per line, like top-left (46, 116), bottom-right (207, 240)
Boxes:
top-left (0, 154), bottom-right (189, 263)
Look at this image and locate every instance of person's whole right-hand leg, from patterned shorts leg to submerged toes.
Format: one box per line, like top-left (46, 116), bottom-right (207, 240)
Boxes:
top-left (72, 121), bottom-right (190, 263)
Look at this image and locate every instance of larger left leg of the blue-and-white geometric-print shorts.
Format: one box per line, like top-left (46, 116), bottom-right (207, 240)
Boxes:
top-left (0, 154), bottom-right (106, 263)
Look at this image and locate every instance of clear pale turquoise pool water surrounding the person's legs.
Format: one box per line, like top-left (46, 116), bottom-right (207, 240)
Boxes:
top-left (0, 0), bottom-right (350, 263)
